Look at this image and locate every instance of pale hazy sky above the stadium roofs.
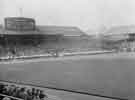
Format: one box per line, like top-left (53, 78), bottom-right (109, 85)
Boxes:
top-left (0, 0), bottom-right (135, 30)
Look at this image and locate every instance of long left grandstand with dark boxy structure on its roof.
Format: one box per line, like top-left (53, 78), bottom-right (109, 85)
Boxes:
top-left (0, 17), bottom-right (99, 58)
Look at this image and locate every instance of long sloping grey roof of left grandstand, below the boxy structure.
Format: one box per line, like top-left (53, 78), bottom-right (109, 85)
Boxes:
top-left (0, 26), bottom-right (86, 36)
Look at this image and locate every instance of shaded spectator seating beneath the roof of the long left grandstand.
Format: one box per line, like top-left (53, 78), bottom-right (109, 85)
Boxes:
top-left (0, 38), bottom-right (103, 60)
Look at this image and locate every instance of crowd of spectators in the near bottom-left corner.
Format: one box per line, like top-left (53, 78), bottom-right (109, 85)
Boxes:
top-left (0, 83), bottom-right (47, 100)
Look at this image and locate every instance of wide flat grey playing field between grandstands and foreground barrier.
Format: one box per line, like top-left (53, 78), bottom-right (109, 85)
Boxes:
top-left (0, 53), bottom-right (135, 99)
